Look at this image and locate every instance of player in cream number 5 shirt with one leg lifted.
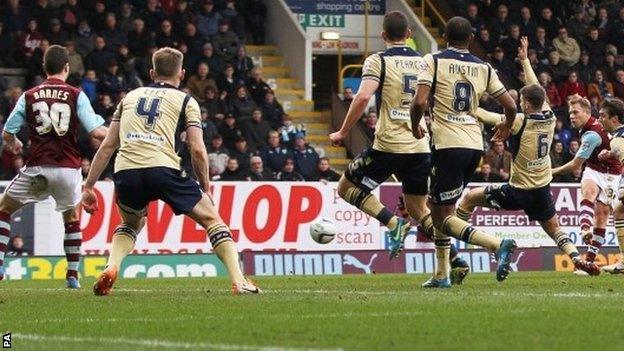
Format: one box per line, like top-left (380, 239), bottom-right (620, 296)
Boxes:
top-left (329, 11), bottom-right (467, 276)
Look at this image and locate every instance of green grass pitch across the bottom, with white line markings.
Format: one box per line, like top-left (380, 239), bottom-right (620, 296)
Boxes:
top-left (0, 272), bottom-right (624, 351)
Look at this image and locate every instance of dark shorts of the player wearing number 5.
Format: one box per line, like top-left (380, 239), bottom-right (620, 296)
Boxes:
top-left (345, 148), bottom-right (431, 195)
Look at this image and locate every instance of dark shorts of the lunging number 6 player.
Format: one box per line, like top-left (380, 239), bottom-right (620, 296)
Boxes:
top-left (485, 184), bottom-right (555, 221)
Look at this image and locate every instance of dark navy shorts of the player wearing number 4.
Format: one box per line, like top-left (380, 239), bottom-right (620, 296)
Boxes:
top-left (114, 167), bottom-right (202, 215)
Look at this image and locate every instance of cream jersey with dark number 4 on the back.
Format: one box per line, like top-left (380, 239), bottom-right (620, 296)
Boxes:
top-left (113, 83), bottom-right (201, 172)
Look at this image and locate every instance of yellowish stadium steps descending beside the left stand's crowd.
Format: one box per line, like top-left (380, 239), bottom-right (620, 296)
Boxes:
top-left (245, 45), bottom-right (350, 172)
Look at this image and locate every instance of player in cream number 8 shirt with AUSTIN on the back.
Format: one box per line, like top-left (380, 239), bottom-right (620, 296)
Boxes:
top-left (411, 17), bottom-right (516, 288)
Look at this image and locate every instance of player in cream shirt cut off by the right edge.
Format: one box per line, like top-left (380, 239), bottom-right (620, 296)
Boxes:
top-left (598, 99), bottom-right (624, 274)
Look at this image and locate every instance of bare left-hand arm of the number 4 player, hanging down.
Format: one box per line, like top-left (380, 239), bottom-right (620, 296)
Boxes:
top-left (82, 120), bottom-right (119, 213)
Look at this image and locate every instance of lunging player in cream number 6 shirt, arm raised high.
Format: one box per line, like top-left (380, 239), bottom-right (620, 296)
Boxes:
top-left (457, 37), bottom-right (600, 275)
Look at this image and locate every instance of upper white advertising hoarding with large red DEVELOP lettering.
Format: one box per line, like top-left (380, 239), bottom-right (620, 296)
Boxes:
top-left (24, 182), bottom-right (617, 256)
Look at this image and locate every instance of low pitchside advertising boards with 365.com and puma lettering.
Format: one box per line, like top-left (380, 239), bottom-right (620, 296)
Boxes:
top-left (0, 247), bottom-right (619, 284)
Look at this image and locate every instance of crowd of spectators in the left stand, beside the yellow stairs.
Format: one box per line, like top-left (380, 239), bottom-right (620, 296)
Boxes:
top-left (0, 0), bottom-right (337, 184)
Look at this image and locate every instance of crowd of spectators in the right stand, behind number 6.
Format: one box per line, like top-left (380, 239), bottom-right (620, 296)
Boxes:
top-left (449, 0), bottom-right (624, 182)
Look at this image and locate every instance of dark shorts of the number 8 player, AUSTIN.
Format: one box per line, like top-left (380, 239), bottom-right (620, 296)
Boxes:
top-left (430, 148), bottom-right (483, 205)
